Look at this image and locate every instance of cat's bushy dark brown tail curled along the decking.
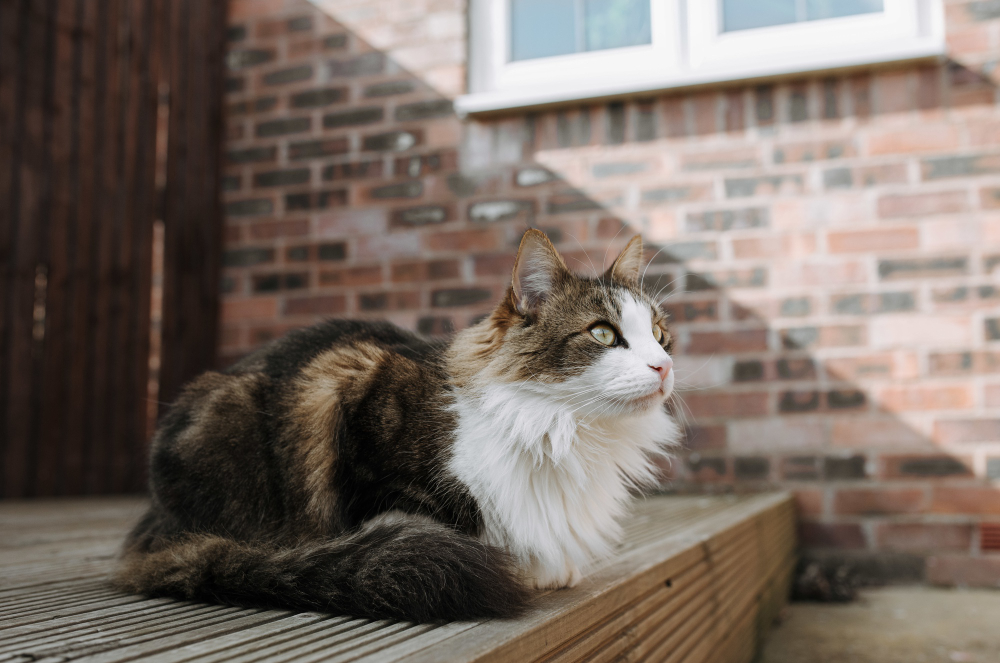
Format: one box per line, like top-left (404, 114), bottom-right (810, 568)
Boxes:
top-left (112, 522), bottom-right (528, 622)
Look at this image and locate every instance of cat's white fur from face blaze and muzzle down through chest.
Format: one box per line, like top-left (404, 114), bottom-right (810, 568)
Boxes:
top-left (449, 295), bottom-right (679, 587)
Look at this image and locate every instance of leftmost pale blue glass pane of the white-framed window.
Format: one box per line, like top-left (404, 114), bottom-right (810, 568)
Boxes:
top-left (510, 0), bottom-right (577, 60)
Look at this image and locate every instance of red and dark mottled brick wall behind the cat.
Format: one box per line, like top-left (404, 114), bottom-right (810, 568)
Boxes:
top-left (220, 0), bottom-right (1000, 584)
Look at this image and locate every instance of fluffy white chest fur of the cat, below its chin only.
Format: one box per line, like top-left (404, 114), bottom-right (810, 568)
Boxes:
top-left (449, 384), bottom-right (678, 587)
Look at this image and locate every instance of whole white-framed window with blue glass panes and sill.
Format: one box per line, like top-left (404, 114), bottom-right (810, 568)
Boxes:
top-left (456, 0), bottom-right (945, 113)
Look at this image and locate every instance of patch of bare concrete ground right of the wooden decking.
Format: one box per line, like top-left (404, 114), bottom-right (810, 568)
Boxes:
top-left (759, 587), bottom-right (1000, 663)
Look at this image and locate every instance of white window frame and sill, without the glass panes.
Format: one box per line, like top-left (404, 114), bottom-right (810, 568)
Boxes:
top-left (455, 0), bottom-right (946, 114)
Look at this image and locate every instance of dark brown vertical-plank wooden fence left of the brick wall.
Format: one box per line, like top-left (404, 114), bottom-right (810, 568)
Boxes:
top-left (0, 0), bottom-right (225, 497)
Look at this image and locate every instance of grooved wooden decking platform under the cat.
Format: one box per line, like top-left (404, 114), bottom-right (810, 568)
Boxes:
top-left (0, 494), bottom-right (794, 663)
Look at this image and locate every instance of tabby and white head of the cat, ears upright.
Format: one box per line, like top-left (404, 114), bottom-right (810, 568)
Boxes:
top-left (450, 229), bottom-right (674, 416)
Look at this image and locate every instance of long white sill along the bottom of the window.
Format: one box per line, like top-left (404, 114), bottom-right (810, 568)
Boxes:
top-left (455, 38), bottom-right (947, 116)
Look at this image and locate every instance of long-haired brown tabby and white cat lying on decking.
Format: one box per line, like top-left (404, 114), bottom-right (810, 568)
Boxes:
top-left (113, 229), bottom-right (679, 622)
